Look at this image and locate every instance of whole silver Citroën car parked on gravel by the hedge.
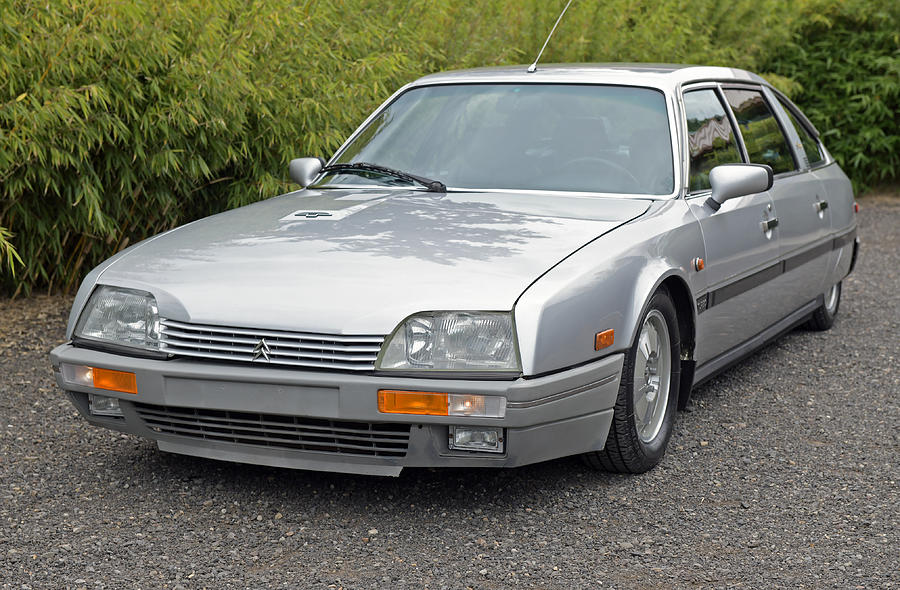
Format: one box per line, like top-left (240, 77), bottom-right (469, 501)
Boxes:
top-left (51, 64), bottom-right (858, 475)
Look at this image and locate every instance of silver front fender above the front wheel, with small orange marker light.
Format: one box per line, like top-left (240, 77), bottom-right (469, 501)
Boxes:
top-left (515, 200), bottom-right (706, 376)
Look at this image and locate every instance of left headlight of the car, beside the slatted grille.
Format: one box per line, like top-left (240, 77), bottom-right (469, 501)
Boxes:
top-left (75, 286), bottom-right (159, 350)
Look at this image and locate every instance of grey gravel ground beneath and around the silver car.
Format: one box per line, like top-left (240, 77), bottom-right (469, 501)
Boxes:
top-left (0, 198), bottom-right (900, 589)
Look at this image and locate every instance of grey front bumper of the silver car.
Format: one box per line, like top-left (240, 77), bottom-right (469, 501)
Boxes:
top-left (50, 344), bottom-right (623, 475)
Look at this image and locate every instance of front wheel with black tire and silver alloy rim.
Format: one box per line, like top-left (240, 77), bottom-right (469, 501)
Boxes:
top-left (582, 288), bottom-right (681, 473)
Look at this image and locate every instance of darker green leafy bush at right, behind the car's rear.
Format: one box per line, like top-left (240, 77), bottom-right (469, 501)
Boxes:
top-left (765, 0), bottom-right (900, 190)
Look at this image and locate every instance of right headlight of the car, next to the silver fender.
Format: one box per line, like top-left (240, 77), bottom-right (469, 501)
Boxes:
top-left (376, 311), bottom-right (519, 371)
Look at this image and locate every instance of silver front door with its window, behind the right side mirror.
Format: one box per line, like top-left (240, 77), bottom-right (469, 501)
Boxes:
top-left (682, 84), bottom-right (780, 366)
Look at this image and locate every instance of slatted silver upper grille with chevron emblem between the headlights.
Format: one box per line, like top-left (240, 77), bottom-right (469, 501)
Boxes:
top-left (160, 320), bottom-right (384, 371)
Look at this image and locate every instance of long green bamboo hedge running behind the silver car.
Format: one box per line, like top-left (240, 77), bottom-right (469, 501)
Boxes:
top-left (0, 0), bottom-right (898, 292)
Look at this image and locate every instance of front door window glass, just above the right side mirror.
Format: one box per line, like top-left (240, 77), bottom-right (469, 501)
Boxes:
top-left (684, 88), bottom-right (741, 192)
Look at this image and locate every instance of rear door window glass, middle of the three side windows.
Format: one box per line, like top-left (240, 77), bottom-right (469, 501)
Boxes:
top-left (725, 89), bottom-right (795, 174)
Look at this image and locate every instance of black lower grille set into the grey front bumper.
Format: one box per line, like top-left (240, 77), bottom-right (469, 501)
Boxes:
top-left (134, 403), bottom-right (409, 457)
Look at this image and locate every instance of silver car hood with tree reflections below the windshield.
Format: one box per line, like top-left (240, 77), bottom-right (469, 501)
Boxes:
top-left (98, 189), bottom-right (651, 335)
